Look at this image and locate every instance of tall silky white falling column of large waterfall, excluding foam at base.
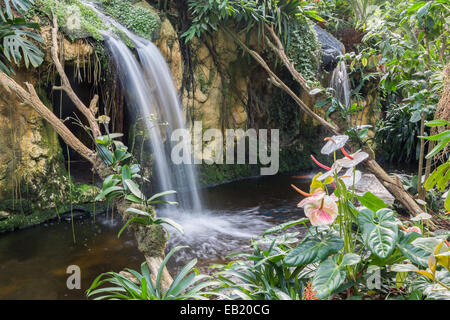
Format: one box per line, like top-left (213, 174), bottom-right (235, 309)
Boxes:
top-left (86, 3), bottom-right (201, 212)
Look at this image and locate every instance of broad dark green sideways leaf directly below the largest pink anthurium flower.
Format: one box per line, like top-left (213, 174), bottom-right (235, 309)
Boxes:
top-left (284, 233), bottom-right (344, 267)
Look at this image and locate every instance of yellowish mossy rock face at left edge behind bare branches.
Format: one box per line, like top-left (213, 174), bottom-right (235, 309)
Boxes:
top-left (0, 31), bottom-right (95, 229)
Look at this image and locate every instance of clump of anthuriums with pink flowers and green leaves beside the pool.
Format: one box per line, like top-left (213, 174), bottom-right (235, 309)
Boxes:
top-left (214, 136), bottom-right (450, 299)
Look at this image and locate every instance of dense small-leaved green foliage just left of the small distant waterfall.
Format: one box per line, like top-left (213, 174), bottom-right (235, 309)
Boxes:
top-left (286, 19), bottom-right (320, 81)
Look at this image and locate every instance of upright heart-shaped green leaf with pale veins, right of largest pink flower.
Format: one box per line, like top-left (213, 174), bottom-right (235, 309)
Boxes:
top-left (358, 209), bottom-right (398, 259)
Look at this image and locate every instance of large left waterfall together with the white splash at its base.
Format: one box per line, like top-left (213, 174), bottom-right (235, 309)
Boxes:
top-left (81, 2), bottom-right (284, 261)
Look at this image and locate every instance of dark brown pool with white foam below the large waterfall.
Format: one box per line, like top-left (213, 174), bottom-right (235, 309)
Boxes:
top-left (0, 175), bottom-right (312, 299)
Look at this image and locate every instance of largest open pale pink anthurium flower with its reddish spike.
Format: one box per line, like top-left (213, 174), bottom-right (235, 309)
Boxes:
top-left (292, 185), bottom-right (338, 226)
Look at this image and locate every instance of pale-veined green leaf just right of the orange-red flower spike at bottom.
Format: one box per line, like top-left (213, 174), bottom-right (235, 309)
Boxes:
top-left (312, 256), bottom-right (345, 299)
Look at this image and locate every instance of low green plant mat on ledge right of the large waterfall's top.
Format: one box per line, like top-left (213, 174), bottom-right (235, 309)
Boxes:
top-left (102, 0), bottom-right (161, 40)
